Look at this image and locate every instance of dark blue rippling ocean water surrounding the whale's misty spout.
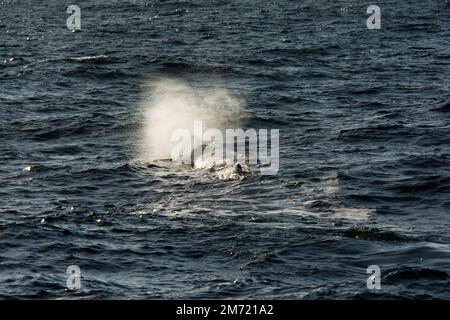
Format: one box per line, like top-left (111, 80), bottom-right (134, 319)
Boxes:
top-left (0, 0), bottom-right (450, 299)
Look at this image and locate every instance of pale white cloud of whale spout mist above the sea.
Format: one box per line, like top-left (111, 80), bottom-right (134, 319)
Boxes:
top-left (140, 78), bottom-right (246, 161)
